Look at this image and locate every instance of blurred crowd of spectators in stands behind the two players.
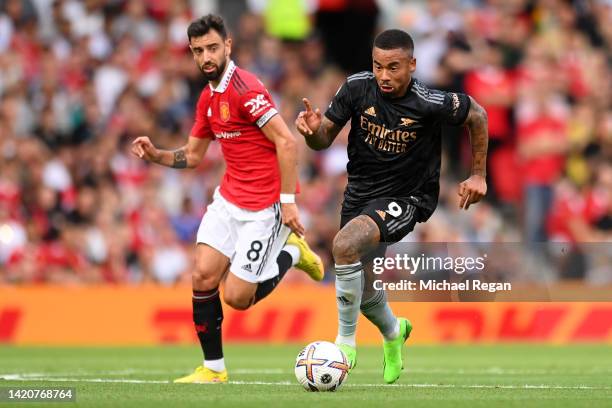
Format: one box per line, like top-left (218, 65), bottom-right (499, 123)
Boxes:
top-left (0, 0), bottom-right (612, 284)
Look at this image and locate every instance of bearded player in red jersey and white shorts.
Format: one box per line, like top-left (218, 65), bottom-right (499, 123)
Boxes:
top-left (132, 15), bottom-right (324, 383)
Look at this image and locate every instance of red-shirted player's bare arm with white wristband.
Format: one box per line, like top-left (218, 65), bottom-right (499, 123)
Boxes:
top-left (261, 115), bottom-right (304, 236)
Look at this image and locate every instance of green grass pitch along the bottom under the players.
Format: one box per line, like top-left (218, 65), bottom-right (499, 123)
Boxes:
top-left (0, 345), bottom-right (612, 408)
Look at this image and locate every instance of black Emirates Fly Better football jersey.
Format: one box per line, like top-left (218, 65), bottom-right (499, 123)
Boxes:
top-left (325, 71), bottom-right (470, 221)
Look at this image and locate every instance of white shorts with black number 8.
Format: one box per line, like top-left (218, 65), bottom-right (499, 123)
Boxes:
top-left (197, 188), bottom-right (291, 283)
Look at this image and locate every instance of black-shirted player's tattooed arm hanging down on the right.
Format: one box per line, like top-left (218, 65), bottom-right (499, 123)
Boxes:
top-left (459, 96), bottom-right (489, 210)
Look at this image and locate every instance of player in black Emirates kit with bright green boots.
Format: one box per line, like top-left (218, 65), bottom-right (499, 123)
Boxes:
top-left (295, 29), bottom-right (488, 383)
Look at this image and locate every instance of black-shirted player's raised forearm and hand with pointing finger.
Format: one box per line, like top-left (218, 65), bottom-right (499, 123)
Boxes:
top-left (295, 98), bottom-right (342, 150)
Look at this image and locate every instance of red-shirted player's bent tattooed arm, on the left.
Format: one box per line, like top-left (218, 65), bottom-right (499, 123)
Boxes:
top-left (132, 136), bottom-right (211, 169)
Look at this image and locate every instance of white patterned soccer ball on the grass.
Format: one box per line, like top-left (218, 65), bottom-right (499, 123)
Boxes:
top-left (295, 341), bottom-right (349, 391)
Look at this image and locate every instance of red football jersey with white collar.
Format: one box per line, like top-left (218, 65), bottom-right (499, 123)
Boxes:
top-left (191, 61), bottom-right (281, 211)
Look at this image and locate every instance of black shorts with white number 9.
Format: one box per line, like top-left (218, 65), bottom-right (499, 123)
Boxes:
top-left (340, 198), bottom-right (421, 244)
